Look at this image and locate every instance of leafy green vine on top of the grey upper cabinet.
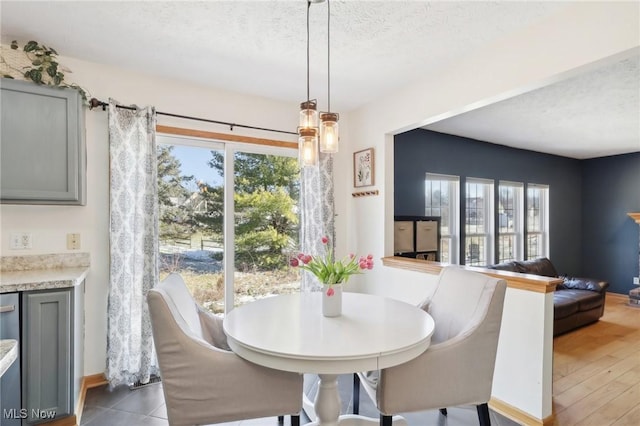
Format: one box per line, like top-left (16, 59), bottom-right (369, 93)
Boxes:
top-left (3, 40), bottom-right (87, 103)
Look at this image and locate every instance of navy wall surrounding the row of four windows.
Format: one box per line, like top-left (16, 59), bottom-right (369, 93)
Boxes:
top-left (394, 129), bottom-right (584, 276)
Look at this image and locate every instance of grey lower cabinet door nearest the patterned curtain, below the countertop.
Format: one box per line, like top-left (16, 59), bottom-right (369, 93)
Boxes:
top-left (21, 289), bottom-right (73, 425)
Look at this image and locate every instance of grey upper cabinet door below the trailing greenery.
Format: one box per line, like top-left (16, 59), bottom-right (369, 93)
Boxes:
top-left (0, 78), bottom-right (86, 205)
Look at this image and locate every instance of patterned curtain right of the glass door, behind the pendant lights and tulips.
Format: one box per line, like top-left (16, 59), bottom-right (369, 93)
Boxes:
top-left (300, 153), bottom-right (335, 292)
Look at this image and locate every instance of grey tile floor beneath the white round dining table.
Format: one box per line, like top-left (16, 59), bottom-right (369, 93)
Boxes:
top-left (81, 375), bottom-right (517, 426)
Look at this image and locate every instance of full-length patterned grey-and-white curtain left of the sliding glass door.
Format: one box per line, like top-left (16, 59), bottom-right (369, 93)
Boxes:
top-left (107, 100), bottom-right (158, 386)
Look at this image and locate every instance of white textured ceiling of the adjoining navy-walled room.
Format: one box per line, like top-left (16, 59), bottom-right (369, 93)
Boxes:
top-left (425, 56), bottom-right (640, 158)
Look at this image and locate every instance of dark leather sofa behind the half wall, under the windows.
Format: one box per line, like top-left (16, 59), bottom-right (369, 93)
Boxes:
top-left (488, 257), bottom-right (609, 336)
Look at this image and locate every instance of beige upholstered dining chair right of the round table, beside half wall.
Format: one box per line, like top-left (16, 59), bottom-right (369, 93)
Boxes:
top-left (353, 266), bottom-right (506, 426)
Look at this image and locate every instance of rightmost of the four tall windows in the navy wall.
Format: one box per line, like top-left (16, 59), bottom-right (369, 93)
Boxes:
top-left (526, 184), bottom-right (549, 259)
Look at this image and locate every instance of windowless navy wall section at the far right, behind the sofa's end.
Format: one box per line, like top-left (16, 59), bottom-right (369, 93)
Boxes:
top-left (582, 152), bottom-right (640, 294)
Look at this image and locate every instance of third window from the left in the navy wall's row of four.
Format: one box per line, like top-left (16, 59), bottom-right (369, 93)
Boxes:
top-left (498, 182), bottom-right (524, 263)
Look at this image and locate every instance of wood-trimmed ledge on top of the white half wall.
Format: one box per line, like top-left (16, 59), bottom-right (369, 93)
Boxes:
top-left (382, 256), bottom-right (562, 293)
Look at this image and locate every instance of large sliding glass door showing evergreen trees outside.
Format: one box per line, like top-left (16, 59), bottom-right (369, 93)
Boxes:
top-left (157, 135), bottom-right (300, 314)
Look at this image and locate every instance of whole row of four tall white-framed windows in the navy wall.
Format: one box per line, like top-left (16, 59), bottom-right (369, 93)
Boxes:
top-left (424, 173), bottom-right (549, 266)
